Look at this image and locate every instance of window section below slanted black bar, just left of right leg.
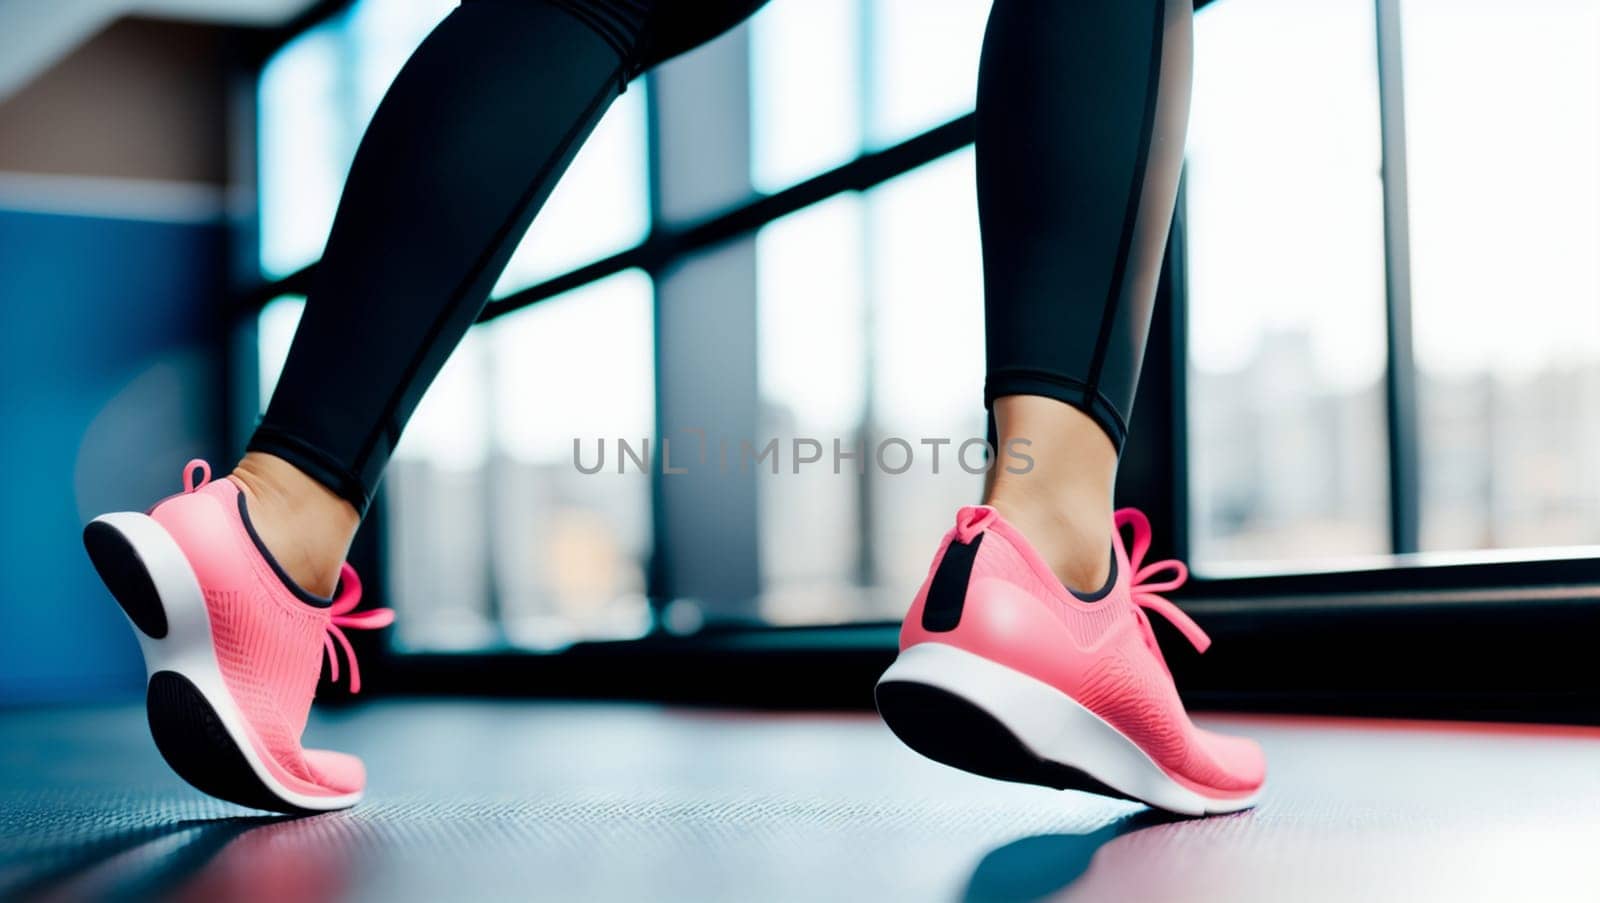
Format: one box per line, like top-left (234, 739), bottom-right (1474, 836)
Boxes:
top-left (757, 151), bottom-right (984, 623)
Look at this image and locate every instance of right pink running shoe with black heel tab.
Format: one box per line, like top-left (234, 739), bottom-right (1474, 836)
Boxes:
top-left (877, 506), bottom-right (1266, 815)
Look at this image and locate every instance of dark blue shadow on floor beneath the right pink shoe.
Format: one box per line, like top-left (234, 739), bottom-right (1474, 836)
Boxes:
top-left (962, 809), bottom-right (1192, 903)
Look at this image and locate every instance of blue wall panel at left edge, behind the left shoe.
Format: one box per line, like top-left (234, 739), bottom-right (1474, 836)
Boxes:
top-left (0, 210), bottom-right (226, 703)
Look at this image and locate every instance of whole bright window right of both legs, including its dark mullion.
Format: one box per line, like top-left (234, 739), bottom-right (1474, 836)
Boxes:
top-left (1187, 0), bottom-right (1600, 570)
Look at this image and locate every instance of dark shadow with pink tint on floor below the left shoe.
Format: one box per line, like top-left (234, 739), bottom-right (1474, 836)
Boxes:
top-left (0, 815), bottom-right (346, 901)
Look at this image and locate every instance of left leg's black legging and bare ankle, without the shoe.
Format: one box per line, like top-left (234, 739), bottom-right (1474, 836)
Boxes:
top-left (232, 0), bottom-right (760, 596)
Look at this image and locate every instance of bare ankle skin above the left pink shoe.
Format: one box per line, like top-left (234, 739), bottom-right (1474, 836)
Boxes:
top-left (229, 452), bottom-right (360, 596)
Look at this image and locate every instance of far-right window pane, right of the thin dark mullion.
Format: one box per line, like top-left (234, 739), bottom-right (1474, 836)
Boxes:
top-left (1400, 0), bottom-right (1600, 551)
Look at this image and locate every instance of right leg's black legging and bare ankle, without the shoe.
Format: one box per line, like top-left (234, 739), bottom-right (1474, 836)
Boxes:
top-left (978, 0), bottom-right (1194, 591)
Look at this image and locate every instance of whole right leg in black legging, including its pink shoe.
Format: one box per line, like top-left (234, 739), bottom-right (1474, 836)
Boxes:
top-left (877, 0), bottom-right (1266, 815)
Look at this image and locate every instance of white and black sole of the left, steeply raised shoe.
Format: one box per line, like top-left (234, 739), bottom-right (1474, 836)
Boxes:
top-left (83, 511), bottom-right (362, 813)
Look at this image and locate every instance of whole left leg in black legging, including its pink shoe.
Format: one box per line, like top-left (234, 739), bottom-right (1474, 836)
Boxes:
top-left (83, 0), bottom-right (777, 813)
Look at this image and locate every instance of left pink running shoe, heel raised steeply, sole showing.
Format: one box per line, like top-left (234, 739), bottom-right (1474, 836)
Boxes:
top-left (83, 460), bottom-right (394, 813)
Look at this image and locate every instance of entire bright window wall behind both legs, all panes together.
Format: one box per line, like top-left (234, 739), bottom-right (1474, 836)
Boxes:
top-left (249, 0), bottom-right (1600, 650)
